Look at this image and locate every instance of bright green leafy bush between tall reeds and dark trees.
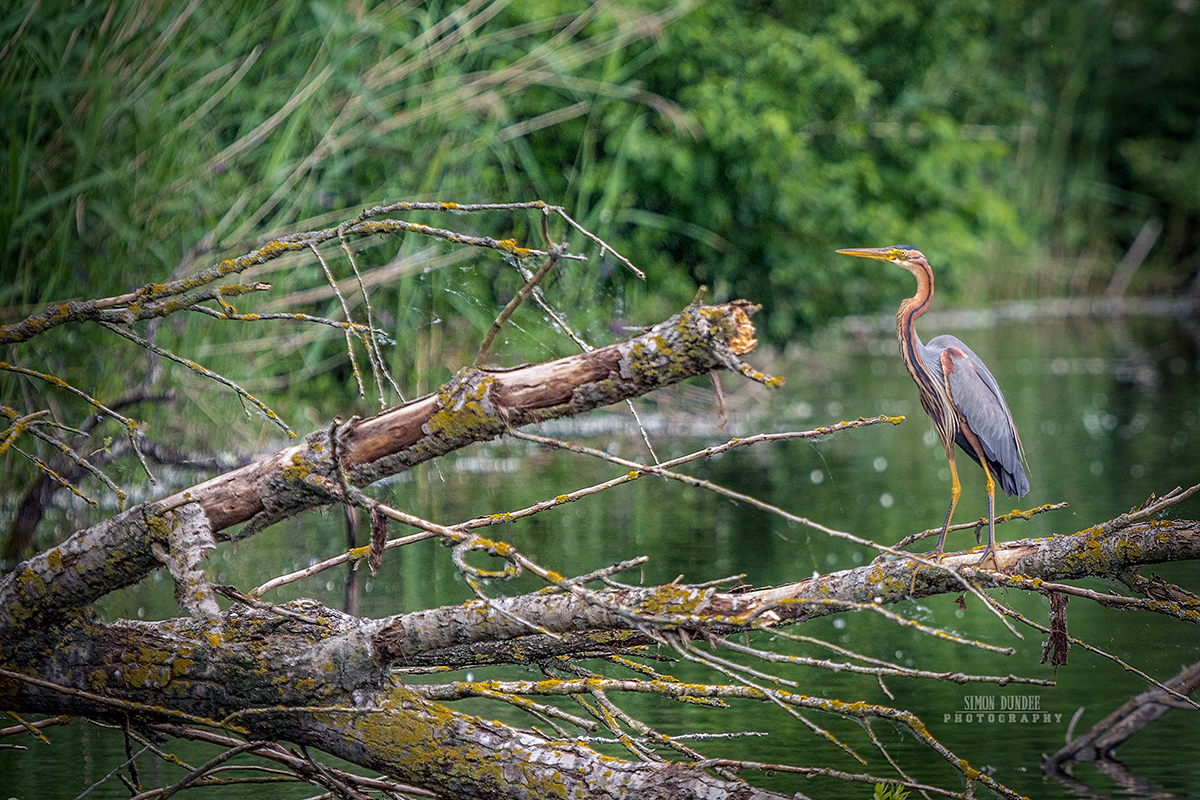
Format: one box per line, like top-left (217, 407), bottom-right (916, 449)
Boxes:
top-left (540, 2), bottom-right (1046, 341)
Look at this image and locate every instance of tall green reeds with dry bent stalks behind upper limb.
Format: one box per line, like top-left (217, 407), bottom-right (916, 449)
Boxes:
top-left (0, 0), bottom-right (690, 551)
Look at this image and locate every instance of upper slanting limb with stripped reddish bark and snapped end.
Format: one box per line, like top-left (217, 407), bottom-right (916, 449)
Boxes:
top-left (0, 301), bottom-right (756, 623)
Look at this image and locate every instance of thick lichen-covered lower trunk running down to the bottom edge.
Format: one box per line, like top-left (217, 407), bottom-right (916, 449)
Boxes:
top-left (0, 601), bottom-right (784, 799)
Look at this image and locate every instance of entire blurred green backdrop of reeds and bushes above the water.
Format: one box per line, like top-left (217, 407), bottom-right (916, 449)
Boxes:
top-left (0, 0), bottom-right (1200, 537)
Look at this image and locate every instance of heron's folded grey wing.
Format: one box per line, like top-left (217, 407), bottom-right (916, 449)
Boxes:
top-left (929, 336), bottom-right (1030, 497)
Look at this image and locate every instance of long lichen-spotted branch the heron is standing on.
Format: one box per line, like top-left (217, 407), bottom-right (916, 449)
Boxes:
top-left (371, 519), bottom-right (1200, 667)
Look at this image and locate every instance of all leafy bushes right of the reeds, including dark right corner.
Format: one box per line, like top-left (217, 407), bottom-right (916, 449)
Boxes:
top-left (600, 2), bottom-right (1200, 341)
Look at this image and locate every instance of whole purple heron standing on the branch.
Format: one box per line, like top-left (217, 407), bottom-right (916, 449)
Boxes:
top-left (838, 246), bottom-right (1030, 561)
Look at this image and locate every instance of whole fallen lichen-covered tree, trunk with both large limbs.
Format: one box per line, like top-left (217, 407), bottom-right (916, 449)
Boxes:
top-left (0, 293), bottom-right (1200, 799)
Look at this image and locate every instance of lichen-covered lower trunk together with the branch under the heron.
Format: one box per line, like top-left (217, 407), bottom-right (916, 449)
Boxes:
top-left (0, 522), bottom-right (1200, 798)
